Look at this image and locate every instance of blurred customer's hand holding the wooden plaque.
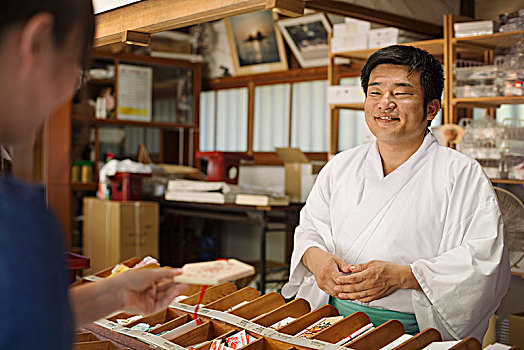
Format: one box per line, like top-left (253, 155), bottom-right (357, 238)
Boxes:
top-left (112, 267), bottom-right (188, 315)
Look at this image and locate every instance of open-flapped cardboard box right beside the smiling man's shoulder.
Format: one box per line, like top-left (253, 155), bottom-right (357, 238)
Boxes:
top-left (276, 148), bottom-right (324, 203)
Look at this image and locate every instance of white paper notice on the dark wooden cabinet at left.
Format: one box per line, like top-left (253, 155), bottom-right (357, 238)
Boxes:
top-left (116, 64), bottom-right (153, 122)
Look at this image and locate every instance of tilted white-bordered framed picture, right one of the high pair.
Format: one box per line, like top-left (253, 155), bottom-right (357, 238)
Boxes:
top-left (277, 13), bottom-right (331, 68)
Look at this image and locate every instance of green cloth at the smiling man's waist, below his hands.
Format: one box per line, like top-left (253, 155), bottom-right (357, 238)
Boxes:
top-left (329, 297), bottom-right (419, 335)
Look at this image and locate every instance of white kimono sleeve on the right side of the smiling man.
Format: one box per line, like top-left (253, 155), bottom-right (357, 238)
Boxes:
top-left (411, 165), bottom-right (510, 340)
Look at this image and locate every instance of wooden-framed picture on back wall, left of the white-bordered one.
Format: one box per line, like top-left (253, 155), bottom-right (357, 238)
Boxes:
top-left (225, 10), bottom-right (287, 75)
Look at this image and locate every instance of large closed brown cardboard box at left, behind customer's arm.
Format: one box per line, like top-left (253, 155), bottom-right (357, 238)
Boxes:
top-left (83, 198), bottom-right (158, 273)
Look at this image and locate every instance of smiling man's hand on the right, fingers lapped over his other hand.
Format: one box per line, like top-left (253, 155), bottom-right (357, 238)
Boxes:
top-left (334, 260), bottom-right (421, 303)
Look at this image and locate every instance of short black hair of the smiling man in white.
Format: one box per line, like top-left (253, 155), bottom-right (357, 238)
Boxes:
top-left (360, 45), bottom-right (444, 126)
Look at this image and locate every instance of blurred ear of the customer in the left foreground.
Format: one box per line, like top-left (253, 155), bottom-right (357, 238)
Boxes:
top-left (18, 12), bottom-right (54, 63)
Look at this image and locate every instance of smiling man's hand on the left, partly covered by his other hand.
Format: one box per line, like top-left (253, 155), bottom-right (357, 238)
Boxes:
top-left (302, 247), bottom-right (349, 297)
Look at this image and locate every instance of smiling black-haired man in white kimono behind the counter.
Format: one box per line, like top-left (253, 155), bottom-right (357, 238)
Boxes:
top-left (282, 45), bottom-right (510, 340)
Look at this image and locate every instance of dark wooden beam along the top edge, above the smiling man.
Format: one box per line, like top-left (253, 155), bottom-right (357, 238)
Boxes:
top-left (306, 0), bottom-right (443, 38)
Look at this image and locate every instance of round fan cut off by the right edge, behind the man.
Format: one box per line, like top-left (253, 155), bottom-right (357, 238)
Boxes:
top-left (494, 187), bottom-right (524, 267)
